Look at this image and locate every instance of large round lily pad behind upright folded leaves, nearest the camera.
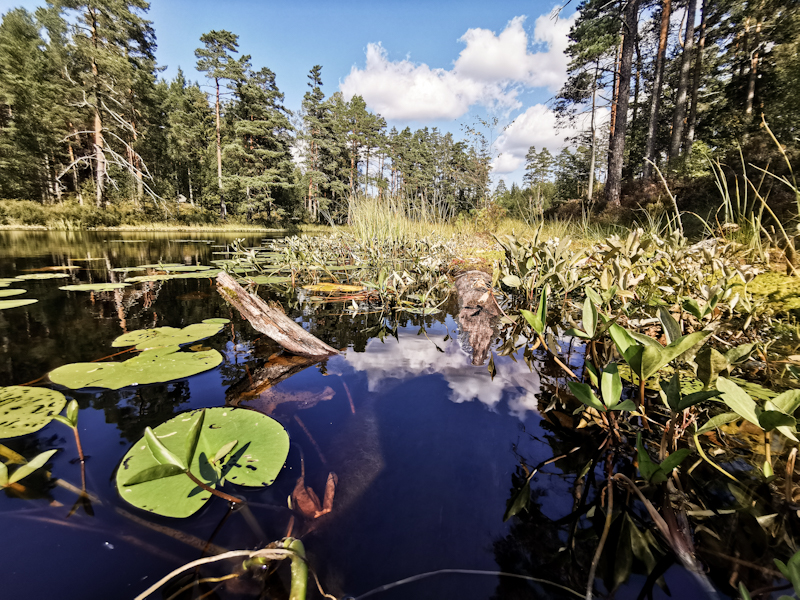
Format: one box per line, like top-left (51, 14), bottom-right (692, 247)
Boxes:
top-left (116, 407), bottom-right (289, 518)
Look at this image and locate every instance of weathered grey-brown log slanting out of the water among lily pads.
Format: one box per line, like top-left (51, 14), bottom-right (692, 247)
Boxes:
top-left (217, 271), bottom-right (338, 358)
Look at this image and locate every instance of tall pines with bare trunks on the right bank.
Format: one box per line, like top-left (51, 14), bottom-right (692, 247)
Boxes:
top-left (555, 0), bottom-right (800, 204)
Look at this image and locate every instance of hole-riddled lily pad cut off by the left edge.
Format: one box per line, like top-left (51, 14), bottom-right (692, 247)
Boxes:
top-left (0, 385), bottom-right (67, 438)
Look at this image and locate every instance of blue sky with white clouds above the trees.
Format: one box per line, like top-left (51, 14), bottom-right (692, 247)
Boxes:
top-left (0, 0), bottom-right (575, 183)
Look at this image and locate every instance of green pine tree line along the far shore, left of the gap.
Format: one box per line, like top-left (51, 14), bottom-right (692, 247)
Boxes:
top-left (0, 0), bottom-right (500, 222)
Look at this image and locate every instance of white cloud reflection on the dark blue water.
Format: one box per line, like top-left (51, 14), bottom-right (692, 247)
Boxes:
top-left (346, 330), bottom-right (539, 419)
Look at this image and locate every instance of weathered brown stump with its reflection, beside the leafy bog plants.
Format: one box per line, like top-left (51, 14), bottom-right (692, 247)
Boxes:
top-left (456, 271), bottom-right (500, 365)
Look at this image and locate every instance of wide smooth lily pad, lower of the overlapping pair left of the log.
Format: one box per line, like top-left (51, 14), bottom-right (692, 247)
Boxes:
top-left (50, 346), bottom-right (222, 390)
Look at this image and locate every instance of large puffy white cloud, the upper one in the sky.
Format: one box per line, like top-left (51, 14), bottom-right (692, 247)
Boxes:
top-left (339, 15), bottom-right (574, 121)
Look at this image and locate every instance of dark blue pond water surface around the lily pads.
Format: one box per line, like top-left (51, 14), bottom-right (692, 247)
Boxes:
top-left (0, 232), bottom-right (712, 600)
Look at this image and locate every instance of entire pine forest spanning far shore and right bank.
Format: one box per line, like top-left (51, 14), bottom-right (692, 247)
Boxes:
top-left (0, 0), bottom-right (800, 223)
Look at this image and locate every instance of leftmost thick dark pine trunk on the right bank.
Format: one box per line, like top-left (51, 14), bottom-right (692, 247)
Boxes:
top-left (606, 0), bottom-right (639, 206)
